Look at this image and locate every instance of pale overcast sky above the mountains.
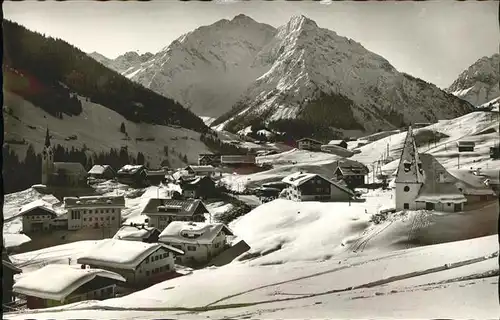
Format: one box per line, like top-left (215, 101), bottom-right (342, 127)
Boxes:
top-left (3, 0), bottom-right (499, 87)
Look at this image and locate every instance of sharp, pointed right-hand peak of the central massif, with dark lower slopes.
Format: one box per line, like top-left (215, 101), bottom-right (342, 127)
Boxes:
top-left (212, 16), bottom-right (472, 137)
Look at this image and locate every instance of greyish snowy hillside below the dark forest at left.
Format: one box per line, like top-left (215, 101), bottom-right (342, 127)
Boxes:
top-left (4, 92), bottom-right (209, 167)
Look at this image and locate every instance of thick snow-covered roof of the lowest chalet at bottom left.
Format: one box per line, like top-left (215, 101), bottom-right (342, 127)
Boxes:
top-left (12, 264), bottom-right (126, 301)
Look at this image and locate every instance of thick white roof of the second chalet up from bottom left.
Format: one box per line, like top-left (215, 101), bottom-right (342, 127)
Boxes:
top-left (78, 239), bottom-right (184, 269)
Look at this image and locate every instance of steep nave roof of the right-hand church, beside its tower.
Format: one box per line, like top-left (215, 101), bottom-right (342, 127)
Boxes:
top-left (415, 153), bottom-right (467, 202)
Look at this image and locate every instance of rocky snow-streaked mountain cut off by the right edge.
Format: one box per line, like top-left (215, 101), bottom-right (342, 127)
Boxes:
top-left (446, 53), bottom-right (500, 106)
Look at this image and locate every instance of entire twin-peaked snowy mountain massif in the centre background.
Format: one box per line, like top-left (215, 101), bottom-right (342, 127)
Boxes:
top-left (92, 15), bottom-right (473, 138)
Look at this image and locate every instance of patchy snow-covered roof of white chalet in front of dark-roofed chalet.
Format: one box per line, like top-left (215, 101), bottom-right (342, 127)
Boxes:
top-left (159, 221), bottom-right (233, 244)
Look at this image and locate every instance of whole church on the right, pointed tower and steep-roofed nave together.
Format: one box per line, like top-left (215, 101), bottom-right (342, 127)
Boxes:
top-left (395, 127), bottom-right (493, 212)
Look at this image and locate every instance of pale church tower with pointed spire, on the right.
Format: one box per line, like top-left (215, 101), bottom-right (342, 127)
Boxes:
top-left (394, 126), bottom-right (424, 210)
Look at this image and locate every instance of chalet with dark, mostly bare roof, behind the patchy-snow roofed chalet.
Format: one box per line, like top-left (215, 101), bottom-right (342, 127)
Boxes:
top-left (142, 198), bottom-right (209, 230)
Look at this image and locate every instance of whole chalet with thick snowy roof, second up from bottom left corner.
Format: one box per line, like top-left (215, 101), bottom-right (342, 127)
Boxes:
top-left (77, 239), bottom-right (184, 287)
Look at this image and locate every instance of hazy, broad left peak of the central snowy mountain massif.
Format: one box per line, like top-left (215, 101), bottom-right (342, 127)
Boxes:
top-left (110, 15), bottom-right (276, 117)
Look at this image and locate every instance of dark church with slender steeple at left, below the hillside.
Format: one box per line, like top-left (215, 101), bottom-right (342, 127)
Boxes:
top-left (42, 129), bottom-right (88, 188)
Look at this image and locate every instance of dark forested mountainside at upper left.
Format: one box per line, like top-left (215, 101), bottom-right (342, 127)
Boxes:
top-left (3, 20), bottom-right (208, 132)
